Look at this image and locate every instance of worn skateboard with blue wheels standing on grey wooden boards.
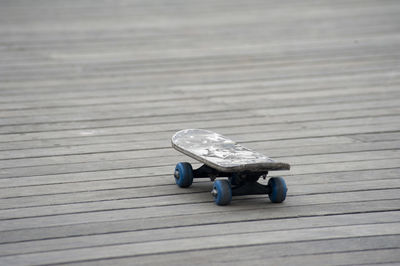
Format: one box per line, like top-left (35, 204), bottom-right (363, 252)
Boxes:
top-left (171, 129), bottom-right (290, 205)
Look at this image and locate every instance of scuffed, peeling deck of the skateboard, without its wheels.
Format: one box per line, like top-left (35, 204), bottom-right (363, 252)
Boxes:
top-left (171, 129), bottom-right (290, 173)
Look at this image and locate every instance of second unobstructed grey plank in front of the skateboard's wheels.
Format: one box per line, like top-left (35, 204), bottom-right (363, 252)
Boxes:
top-left (0, 212), bottom-right (400, 256)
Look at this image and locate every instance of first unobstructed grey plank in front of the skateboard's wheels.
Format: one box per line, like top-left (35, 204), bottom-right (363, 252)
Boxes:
top-left (0, 197), bottom-right (399, 243)
